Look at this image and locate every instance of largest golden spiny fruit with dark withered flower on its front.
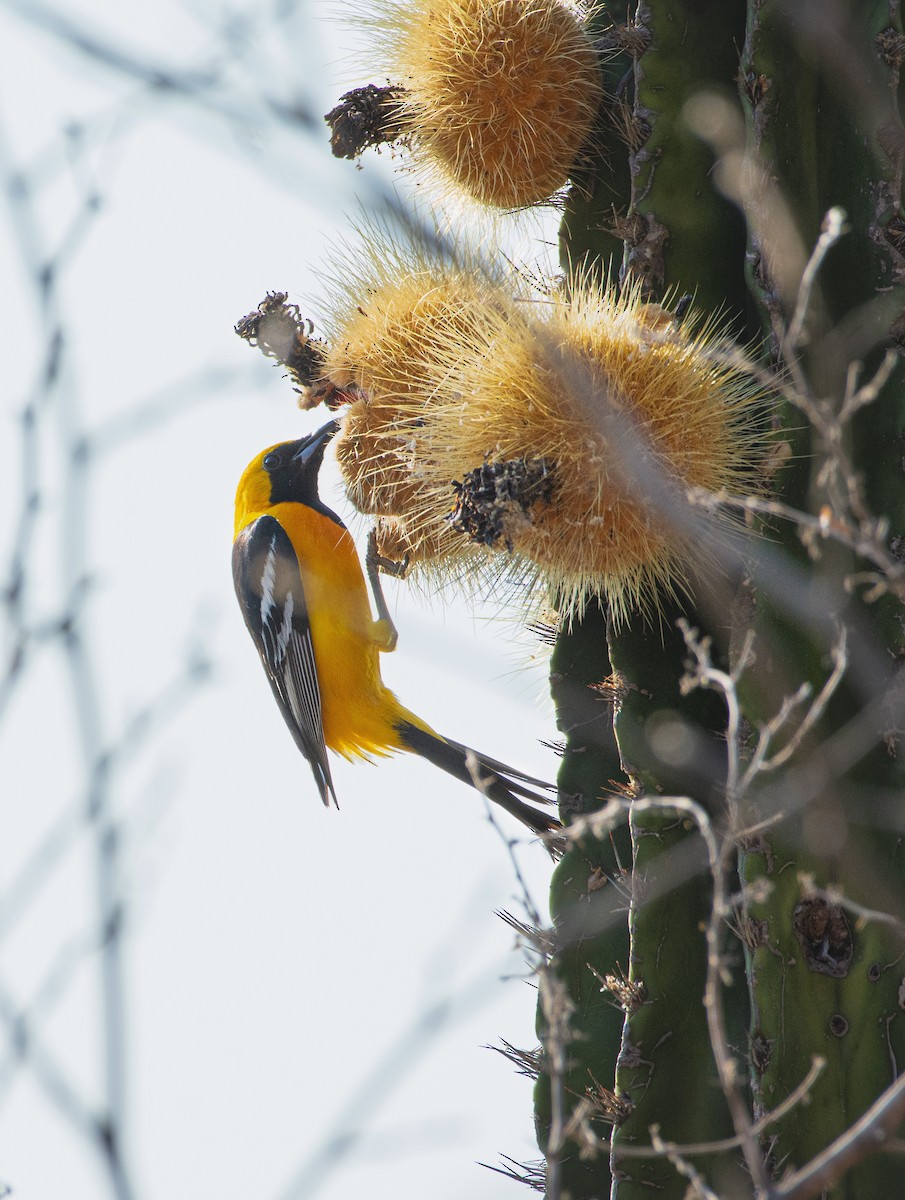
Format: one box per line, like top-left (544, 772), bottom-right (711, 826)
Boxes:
top-left (421, 280), bottom-right (763, 619)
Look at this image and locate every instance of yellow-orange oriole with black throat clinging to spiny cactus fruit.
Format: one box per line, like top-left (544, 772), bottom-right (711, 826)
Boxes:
top-left (233, 421), bottom-right (558, 833)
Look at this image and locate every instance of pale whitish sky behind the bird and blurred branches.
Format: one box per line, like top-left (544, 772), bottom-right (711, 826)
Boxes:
top-left (0, 0), bottom-right (557, 1200)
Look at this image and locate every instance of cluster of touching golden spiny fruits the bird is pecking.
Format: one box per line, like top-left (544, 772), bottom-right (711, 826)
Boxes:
top-left (314, 237), bottom-right (765, 619)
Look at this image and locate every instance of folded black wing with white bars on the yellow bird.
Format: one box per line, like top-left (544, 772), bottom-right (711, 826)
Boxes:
top-left (233, 516), bottom-right (336, 804)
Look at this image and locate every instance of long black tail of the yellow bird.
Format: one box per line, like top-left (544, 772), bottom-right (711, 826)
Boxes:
top-left (396, 721), bottom-right (562, 833)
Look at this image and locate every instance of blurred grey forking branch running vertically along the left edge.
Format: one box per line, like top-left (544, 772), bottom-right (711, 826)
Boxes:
top-left (0, 32), bottom-right (218, 1200)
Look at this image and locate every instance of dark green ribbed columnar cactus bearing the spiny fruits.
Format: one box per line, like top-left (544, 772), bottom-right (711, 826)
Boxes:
top-left (537, 0), bottom-right (905, 1200)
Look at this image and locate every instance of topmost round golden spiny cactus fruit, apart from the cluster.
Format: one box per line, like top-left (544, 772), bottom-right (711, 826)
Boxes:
top-left (359, 0), bottom-right (603, 209)
